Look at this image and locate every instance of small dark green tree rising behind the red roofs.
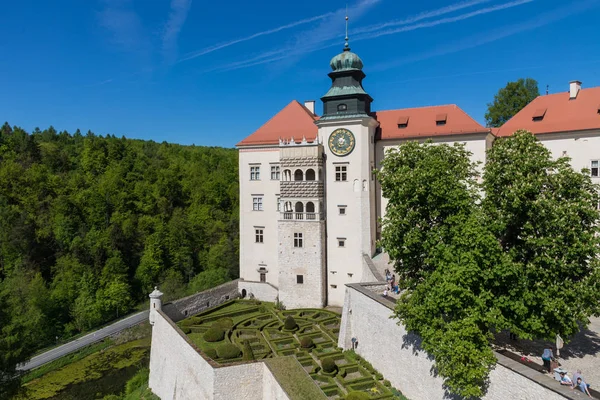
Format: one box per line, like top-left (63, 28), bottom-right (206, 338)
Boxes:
top-left (485, 78), bottom-right (540, 128)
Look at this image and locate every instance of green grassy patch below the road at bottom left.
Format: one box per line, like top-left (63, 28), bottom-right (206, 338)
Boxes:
top-left (24, 338), bottom-right (150, 400)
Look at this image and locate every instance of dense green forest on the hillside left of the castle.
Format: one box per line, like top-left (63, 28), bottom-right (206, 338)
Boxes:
top-left (0, 123), bottom-right (238, 380)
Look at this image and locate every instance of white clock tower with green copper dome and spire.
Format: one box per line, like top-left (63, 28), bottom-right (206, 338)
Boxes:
top-left (316, 35), bottom-right (378, 306)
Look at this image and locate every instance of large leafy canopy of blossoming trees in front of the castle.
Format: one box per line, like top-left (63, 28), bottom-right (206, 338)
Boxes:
top-left (379, 132), bottom-right (600, 398)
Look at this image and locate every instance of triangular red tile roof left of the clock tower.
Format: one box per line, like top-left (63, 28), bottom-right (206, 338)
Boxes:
top-left (237, 100), bottom-right (318, 146)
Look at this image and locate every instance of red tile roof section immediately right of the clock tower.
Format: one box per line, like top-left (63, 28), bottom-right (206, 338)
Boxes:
top-left (374, 104), bottom-right (490, 140)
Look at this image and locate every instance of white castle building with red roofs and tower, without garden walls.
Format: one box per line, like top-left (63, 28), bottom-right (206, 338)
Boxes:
top-left (237, 36), bottom-right (600, 308)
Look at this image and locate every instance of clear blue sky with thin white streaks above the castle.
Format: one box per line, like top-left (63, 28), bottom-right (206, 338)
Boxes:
top-left (0, 0), bottom-right (600, 147)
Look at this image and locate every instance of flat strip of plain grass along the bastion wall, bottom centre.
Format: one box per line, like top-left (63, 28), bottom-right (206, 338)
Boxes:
top-left (265, 357), bottom-right (327, 400)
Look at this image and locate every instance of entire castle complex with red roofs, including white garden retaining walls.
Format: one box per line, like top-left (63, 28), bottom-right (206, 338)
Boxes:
top-left (149, 33), bottom-right (600, 400)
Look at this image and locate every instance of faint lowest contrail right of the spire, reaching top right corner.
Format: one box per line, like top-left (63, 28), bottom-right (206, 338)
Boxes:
top-left (372, 0), bottom-right (600, 71)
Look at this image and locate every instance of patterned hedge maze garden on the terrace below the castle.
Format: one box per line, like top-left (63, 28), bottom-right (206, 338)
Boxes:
top-left (178, 300), bottom-right (404, 399)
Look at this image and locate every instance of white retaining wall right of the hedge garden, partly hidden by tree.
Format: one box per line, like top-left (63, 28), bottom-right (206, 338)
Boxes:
top-left (338, 283), bottom-right (577, 400)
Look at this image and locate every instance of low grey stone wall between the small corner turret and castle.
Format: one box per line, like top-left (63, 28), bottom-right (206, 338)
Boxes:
top-left (162, 279), bottom-right (239, 322)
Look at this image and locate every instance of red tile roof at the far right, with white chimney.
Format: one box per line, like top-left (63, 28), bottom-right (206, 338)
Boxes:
top-left (497, 87), bottom-right (600, 136)
